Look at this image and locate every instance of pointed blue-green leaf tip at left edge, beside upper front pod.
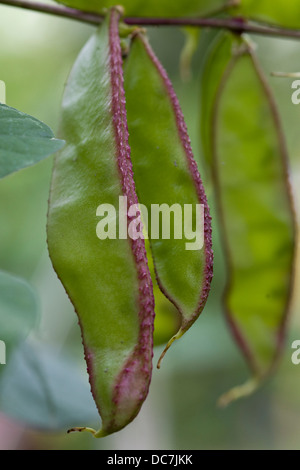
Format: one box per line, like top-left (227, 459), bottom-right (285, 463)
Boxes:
top-left (0, 103), bottom-right (64, 178)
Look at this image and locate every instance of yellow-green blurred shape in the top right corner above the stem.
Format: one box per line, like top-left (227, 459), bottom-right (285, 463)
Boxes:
top-left (233, 0), bottom-right (300, 28)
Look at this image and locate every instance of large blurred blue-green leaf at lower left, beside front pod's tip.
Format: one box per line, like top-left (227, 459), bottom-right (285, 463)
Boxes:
top-left (0, 343), bottom-right (99, 431)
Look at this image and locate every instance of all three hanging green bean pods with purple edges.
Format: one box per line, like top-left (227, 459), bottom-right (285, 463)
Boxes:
top-left (48, 0), bottom-right (296, 437)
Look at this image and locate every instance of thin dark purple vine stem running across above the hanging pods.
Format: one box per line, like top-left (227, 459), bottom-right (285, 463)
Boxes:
top-left (0, 0), bottom-right (300, 39)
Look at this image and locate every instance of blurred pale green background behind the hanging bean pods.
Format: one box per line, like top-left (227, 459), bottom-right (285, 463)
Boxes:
top-left (0, 0), bottom-right (300, 450)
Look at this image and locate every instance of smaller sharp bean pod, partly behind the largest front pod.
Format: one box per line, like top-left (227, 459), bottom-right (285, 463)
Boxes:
top-left (124, 33), bottom-right (213, 367)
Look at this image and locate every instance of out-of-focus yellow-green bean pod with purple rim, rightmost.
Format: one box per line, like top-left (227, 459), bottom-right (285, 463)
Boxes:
top-left (212, 39), bottom-right (295, 403)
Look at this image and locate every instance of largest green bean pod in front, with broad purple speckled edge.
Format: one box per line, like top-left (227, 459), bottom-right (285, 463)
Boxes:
top-left (48, 9), bottom-right (154, 437)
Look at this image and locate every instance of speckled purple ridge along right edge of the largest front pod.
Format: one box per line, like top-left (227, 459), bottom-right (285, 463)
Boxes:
top-left (105, 9), bottom-right (155, 432)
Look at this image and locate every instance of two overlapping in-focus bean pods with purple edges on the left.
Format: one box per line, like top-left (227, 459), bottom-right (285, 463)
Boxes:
top-left (48, 8), bottom-right (213, 437)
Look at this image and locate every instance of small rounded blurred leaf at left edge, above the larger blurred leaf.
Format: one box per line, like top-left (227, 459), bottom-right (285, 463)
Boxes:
top-left (0, 271), bottom-right (40, 348)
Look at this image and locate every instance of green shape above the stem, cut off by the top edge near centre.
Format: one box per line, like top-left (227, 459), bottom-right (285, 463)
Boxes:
top-left (57, 0), bottom-right (228, 17)
